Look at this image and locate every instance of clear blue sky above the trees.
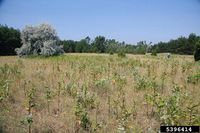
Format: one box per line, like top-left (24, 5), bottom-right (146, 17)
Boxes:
top-left (0, 0), bottom-right (200, 44)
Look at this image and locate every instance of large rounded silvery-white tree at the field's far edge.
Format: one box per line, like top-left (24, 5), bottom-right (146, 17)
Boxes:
top-left (16, 24), bottom-right (64, 56)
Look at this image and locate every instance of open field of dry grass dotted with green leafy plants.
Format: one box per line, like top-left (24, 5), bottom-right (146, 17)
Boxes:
top-left (0, 54), bottom-right (200, 133)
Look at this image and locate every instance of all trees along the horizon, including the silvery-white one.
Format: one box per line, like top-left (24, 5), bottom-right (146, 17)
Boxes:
top-left (0, 24), bottom-right (200, 56)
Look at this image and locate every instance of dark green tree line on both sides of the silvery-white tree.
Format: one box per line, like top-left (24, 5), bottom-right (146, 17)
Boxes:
top-left (0, 25), bottom-right (200, 55)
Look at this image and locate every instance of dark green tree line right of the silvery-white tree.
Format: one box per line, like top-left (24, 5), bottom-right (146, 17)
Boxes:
top-left (61, 33), bottom-right (200, 55)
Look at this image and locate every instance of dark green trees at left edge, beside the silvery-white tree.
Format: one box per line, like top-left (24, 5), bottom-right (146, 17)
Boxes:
top-left (0, 25), bottom-right (22, 55)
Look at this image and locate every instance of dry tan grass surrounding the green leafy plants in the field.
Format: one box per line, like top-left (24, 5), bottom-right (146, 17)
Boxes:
top-left (0, 54), bottom-right (200, 133)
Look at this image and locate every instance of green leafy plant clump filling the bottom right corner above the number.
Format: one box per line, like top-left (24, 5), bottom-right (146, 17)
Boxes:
top-left (145, 86), bottom-right (200, 125)
